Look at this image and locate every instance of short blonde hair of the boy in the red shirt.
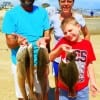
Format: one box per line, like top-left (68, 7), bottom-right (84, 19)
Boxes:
top-left (61, 17), bottom-right (78, 30)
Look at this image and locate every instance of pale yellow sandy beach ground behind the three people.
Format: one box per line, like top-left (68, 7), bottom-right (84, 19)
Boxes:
top-left (0, 11), bottom-right (100, 100)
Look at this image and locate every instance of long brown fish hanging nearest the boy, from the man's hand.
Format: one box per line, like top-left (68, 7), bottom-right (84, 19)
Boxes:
top-left (37, 47), bottom-right (50, 100)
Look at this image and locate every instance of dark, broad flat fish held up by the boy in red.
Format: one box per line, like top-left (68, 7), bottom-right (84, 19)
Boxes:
top-left (59, 52), bottom-right (79, 97)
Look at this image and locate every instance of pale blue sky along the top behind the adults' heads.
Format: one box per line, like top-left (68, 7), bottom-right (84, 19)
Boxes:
top-left (0, 0), bottom-right (100, 9)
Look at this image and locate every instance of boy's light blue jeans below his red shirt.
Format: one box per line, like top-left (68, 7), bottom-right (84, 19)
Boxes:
top-left (59, 87), bottom-right (89, 100)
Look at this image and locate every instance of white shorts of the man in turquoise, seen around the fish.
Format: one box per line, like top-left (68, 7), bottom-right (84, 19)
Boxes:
top-left (11, 64), bottom-right (41, 98)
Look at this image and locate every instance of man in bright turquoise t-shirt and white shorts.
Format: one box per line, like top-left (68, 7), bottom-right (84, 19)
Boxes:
top-left (2, 0), bottom-right (50, 100)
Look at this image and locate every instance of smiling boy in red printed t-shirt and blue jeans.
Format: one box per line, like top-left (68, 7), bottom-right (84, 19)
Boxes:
top-left (49, 17), bottom-right (98, 100)
